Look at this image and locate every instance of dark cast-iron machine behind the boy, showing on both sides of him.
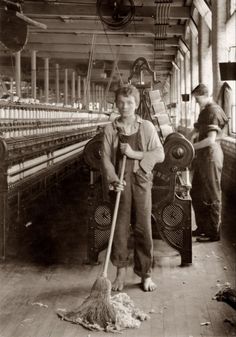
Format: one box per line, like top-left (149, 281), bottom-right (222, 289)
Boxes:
top-left (84, 58), bottom-right (194, 266)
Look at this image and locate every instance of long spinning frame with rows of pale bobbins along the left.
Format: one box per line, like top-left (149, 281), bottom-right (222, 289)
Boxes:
top-left (0, 103), bottom-right (108, 259)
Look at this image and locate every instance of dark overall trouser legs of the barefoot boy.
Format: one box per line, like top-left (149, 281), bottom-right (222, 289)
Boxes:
top-left (111, 171), bottom-right (153, 278)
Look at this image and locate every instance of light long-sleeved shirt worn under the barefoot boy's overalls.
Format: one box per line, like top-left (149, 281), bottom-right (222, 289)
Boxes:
top-left (101, 115), bottom-right (164, 183)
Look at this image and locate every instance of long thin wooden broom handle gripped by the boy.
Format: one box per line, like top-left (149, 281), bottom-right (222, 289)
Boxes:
top-left (102, 155), bottom-right (126, 277)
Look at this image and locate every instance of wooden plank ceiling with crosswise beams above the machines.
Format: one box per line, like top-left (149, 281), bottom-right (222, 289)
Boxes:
top-left (0, 0), bottom-right (192, 93)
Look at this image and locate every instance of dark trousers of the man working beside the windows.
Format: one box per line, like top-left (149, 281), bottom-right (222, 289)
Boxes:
top-left (191, 143), bottom-right (223, 238)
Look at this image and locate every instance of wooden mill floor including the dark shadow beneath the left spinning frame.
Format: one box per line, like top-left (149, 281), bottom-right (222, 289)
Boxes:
top-left (0, 171), bottom-right (236, 337)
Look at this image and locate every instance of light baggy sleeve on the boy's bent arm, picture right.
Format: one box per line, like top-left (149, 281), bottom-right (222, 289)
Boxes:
top-left (139, 121), bottom-right (165, 173)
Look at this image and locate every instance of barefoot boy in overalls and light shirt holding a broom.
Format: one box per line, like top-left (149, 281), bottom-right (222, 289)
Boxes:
top-left (102, 85), bottom-right (164, 291)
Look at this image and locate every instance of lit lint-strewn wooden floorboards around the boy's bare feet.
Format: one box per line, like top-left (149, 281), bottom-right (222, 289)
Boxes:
top-left (0, 242), bottom-right (236, 337)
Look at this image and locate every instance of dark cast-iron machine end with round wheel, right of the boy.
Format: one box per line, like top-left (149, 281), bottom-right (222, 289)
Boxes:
top-left (152, 133), bottom-right (194, 265)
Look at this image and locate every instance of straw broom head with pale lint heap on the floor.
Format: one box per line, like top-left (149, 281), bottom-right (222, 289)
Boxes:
top-left (57, 277), bottom-right (149, 332)
